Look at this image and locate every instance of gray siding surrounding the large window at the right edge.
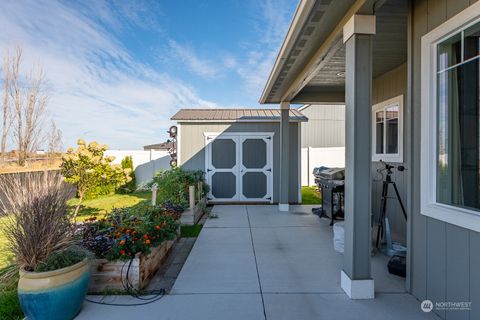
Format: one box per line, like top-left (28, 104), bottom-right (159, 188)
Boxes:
top-left (410, 0), bottom-right (480, 319)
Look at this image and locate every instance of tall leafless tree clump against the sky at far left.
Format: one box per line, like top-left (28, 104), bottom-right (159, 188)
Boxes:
top-left (3, 46), bottom-right (49, 165)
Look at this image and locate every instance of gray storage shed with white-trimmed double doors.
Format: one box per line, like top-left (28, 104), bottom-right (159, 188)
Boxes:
top-left (171, 109), bottom-right (308, 203)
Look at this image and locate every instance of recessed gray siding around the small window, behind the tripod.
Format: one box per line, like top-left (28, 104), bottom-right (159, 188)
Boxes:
top-left (372, 63), bottom-right (408, 244)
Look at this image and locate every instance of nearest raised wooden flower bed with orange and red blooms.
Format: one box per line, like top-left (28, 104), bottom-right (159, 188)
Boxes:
top-left (82, 202), bottom-right (180, 293)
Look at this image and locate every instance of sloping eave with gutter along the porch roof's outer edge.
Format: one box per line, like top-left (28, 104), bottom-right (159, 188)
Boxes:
top-left (260, 0), bottom-right (369, 104)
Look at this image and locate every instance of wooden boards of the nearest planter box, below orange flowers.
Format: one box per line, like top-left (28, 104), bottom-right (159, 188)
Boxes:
top-left (88, 237), bottom-right (177, 293)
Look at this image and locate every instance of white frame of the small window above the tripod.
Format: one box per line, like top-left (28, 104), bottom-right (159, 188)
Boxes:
top-left (372, 95), bottom-right (403, 163)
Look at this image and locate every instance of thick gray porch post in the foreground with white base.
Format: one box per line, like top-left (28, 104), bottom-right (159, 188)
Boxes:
top-left (341, 15), bottom-right (375, 299)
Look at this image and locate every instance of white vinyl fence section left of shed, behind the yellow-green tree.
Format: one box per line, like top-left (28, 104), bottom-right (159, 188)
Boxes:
top-left (105, 150), bottom-right (170, 187)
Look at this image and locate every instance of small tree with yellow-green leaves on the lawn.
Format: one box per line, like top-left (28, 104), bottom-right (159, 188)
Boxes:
top-left (60, 139), bottom-right (131, 222)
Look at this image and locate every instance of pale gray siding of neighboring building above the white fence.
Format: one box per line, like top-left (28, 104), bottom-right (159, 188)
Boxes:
top-left (301, 104), bottom-right (345, 148)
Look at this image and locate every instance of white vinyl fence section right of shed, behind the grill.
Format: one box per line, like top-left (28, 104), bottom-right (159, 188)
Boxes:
top-left (301, 147), bottom-right (345, 186)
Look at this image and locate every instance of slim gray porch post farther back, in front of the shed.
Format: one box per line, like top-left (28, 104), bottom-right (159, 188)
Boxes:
top-left (278, 102), bottom-right (290, 211)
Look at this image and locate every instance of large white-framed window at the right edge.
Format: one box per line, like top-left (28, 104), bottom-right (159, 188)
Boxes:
top-left (421, 4), bottom-right (480, 231)
